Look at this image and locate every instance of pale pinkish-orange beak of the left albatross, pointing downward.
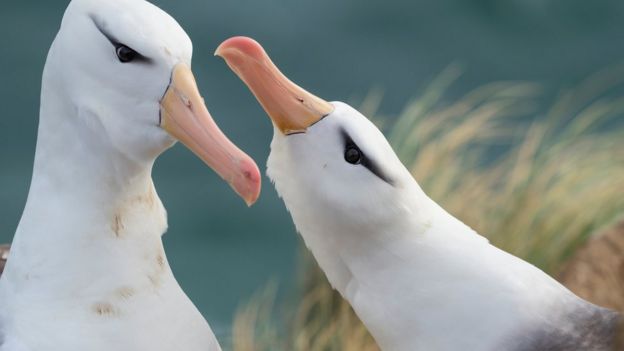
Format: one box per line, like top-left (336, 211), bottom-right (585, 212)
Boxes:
top-left (160, 64), bottom-right (260, 206)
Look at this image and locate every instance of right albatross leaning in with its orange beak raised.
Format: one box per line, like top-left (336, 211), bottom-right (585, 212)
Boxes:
top-left (216, 37), bottom-right (621, 351)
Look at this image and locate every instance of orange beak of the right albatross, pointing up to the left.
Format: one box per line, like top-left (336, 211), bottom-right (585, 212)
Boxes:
top-left (215, 37), bottom-right (334, 135)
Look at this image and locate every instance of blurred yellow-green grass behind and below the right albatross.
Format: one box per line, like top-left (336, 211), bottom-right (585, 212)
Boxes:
top-left (232, 65), bottom-right (624, 351)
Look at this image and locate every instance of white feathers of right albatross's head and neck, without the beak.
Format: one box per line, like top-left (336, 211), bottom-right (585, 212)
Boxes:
top-left (268, 103), bottom-right (600, 351)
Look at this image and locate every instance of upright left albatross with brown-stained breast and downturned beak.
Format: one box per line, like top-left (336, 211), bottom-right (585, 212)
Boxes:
top-left (0, 0), bottom-right (260, 351)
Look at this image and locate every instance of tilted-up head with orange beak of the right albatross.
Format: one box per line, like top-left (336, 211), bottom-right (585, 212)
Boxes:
top-left (216, 37), bottom-right (417, 235)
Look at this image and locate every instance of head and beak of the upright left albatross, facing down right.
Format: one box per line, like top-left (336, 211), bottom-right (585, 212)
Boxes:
top-left (42, 0), bottom-right (260, 204)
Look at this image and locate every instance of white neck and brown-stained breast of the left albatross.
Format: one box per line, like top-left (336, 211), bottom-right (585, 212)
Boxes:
top-left (0, 31), bottom-right (220, 351)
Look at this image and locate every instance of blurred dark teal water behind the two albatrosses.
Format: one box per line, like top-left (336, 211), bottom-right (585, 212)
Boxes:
top-left (0, 0), bottom-right (624, 334)
